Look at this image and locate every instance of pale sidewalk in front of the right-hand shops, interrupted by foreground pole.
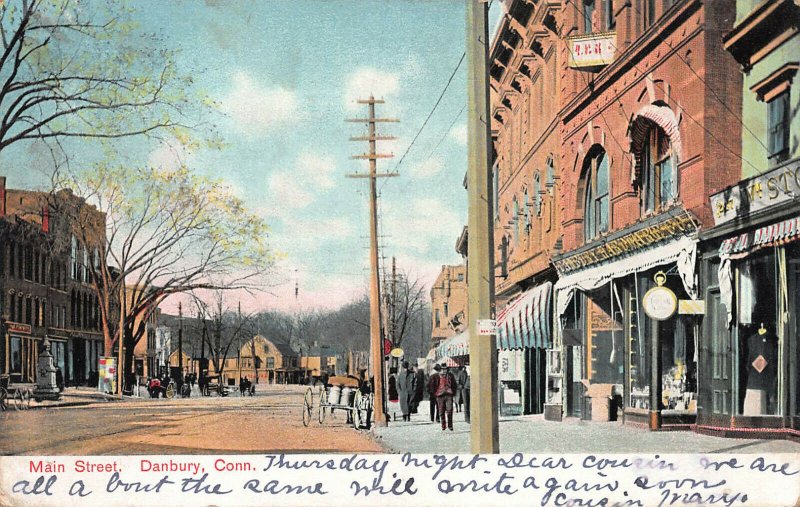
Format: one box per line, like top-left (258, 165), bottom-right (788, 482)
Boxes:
top-left (372, 400), bottom-right (800, 454)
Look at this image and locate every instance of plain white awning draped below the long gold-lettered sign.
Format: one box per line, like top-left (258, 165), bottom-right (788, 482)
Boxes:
top-left (555, 236), bottom-right (697, 315)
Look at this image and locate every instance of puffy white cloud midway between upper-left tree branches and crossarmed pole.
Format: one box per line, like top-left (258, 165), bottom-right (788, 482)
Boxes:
top-left (222, 72), bottom-right (300, 136)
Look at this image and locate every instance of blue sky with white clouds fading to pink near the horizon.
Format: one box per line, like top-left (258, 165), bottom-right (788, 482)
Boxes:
top-left (8, 0), bottom-right (500, 311)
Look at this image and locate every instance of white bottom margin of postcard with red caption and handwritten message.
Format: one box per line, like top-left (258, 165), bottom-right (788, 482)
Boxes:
top-left (0, 454), bottom-right (800, 507)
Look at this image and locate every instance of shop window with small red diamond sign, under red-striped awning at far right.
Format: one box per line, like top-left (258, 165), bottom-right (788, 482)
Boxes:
top-left (736, 251), bottom-right (779, 416)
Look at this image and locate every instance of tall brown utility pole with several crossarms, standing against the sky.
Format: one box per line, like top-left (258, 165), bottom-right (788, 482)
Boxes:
top-left (347, 95), bottom-right (399, 426)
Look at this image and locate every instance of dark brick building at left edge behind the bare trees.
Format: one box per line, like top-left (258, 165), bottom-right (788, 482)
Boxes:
top-left (0, 176), bottom-right (105, 384)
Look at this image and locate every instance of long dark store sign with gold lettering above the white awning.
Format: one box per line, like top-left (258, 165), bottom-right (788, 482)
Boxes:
top-left (555, 215), bottom-right (697, 275)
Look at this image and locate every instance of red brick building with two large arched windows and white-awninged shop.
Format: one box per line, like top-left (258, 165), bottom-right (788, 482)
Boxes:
top-left (555, 0), bottom-right (742, 429)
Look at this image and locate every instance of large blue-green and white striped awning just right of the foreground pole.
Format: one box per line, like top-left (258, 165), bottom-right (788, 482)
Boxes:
top-left (497, 282), bottom-right (553, 350)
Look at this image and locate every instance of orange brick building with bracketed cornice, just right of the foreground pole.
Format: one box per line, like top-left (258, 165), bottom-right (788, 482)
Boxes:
top-left (489, 0), bottom-right (564, 413)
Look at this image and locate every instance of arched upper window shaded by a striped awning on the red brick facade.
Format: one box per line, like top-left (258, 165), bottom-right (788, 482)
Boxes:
top-left (640, 122), bottom-right (677, 213)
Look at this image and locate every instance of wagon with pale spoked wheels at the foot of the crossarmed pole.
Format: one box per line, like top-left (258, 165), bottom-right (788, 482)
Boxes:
top-left (303, 375), bottom-right (374, 429)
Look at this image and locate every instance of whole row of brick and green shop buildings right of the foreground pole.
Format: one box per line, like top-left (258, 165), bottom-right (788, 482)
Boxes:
top-left (439, 0), bottom-right (800, 438)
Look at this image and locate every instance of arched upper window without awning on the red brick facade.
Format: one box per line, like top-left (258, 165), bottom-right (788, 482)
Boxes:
top-left (583, 148), bottom-right (609, 241)
